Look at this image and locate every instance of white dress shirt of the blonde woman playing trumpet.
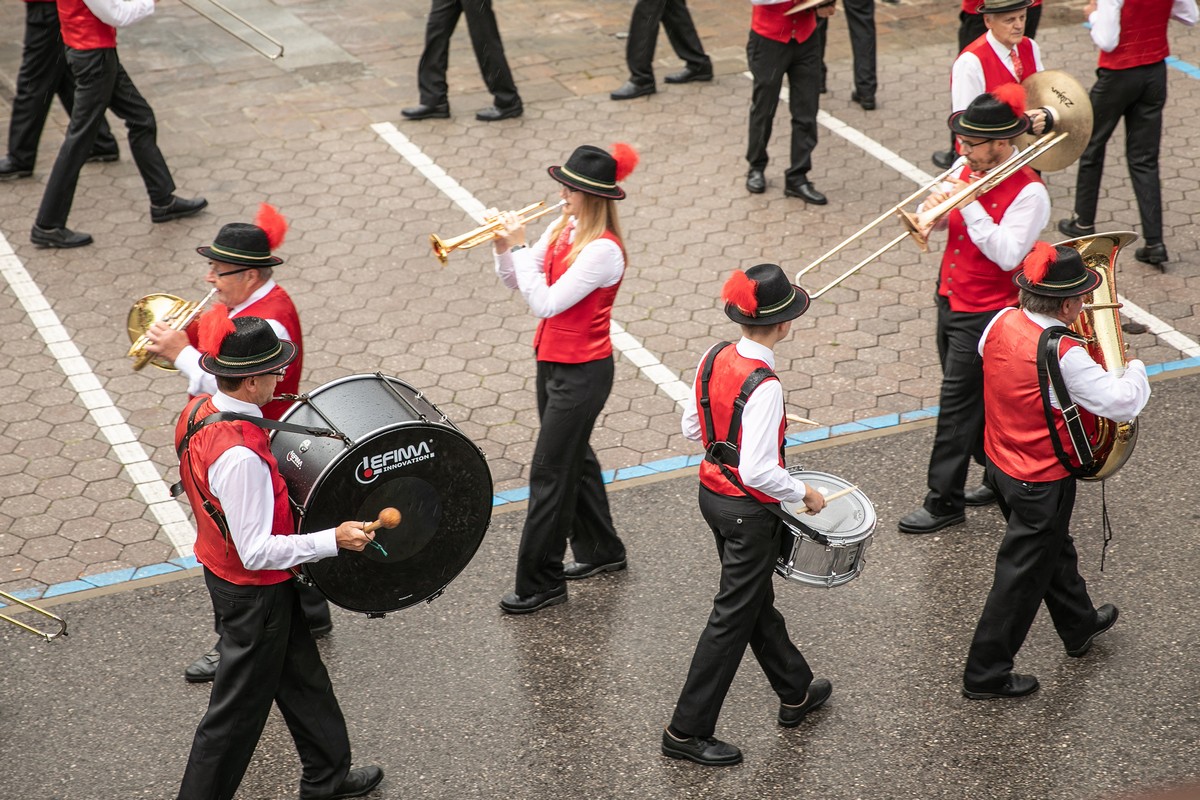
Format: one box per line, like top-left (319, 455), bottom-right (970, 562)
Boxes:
top-left (494, 217), bottom-right (625, 319)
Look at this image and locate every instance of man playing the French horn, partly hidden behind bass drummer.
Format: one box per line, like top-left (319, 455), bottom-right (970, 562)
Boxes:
top-left (146, 203), bottom-right (334, 684)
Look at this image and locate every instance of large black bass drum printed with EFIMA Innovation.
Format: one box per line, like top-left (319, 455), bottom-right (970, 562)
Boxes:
top-left (271, 373), bottom-right (492, 615)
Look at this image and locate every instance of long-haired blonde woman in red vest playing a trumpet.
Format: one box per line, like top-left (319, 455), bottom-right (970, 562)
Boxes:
top-left (494, 144), bottom-right (637, 614)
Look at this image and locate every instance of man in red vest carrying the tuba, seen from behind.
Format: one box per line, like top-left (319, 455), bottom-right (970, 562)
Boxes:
top-left (962, 242), bottom-right (1150, 699)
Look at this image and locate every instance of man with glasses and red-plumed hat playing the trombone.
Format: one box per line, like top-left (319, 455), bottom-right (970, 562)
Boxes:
top-left (899, 84), bottom-right (1050, 534)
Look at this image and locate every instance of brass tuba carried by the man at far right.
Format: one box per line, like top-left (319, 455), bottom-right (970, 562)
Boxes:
top-left (1058, 231), bottom-right (1138, 481)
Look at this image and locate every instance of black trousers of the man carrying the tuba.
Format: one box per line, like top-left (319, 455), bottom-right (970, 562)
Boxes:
top-left (962, 464), bottom-right (1096, 692)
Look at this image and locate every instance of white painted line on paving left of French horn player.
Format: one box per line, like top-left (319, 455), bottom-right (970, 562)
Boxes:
top-left (0, 234), bottom-right (196, 555)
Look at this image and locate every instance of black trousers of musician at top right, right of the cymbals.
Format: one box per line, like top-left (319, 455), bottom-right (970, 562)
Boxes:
top-left (1075, 61), bottom-right (1166, 245)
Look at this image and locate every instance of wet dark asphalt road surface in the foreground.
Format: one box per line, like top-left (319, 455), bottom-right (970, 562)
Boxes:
top-left (0, 374), bottom-right (1200, 800)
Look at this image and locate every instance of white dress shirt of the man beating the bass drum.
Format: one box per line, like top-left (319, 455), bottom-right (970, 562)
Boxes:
top-left (200, 392), bottom-right (337, 570)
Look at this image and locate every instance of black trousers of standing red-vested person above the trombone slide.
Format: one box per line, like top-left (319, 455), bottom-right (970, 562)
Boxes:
top-left (746, 31), bottom-right (821, 185)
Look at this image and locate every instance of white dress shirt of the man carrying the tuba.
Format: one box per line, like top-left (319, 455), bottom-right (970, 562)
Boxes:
top-left (979, 308), bottom-right (1150, 422)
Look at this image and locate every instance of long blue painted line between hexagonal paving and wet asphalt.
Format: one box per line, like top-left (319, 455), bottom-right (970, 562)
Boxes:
top-left (14, 357), bottom-right (1200, 608)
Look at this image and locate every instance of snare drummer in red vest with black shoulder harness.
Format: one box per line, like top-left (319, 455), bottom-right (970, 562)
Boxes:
top-left (662, 264), bottom-right (833, 766)
